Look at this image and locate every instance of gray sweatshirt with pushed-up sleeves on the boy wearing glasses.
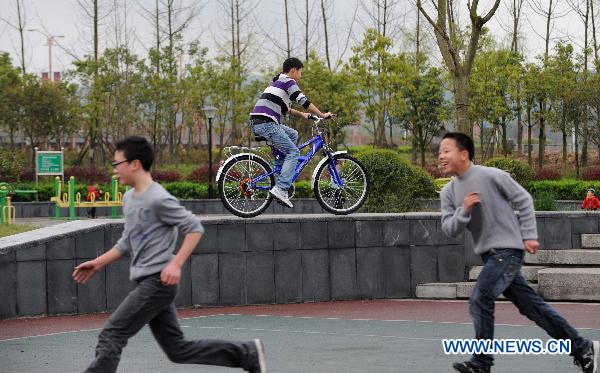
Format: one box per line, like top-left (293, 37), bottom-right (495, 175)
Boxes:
top-left (116, 182), bottom-right (204, 280)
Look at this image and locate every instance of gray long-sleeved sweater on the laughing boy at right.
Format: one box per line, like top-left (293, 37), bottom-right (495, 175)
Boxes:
top-left (441, 164), bottom-right (537, 254)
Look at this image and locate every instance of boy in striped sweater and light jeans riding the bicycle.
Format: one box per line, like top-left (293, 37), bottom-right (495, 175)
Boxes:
top-left (250, 57), bottom-right (333, 208)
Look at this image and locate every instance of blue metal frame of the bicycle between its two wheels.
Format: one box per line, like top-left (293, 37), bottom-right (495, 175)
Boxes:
top-left (252, 128), bottom-right (344, 190)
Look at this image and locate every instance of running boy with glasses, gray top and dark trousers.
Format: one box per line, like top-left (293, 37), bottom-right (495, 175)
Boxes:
top-left (73, 136), bottom-right (266, 373)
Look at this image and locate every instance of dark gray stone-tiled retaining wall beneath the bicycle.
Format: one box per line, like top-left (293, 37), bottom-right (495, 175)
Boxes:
top-left (0, 212), bottom-right (600, 319)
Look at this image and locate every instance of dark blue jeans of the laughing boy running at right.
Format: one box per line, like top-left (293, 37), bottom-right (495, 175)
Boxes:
top-left (469, 249), bottom-right (591, 367)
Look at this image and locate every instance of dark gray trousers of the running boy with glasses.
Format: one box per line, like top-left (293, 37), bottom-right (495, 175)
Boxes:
top-left (86, 274), bottom-right (251, 373)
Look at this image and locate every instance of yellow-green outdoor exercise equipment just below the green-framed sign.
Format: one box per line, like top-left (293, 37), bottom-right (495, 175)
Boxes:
top-left (50, 176), bottom-right (127, 219)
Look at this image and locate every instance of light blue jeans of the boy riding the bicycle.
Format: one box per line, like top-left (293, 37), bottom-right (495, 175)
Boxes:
top-left (252, 122), bottom-right (300, 190)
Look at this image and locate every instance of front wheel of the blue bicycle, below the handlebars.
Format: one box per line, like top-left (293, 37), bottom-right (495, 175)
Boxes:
top-left (314, 154), bottom-right (369, 215)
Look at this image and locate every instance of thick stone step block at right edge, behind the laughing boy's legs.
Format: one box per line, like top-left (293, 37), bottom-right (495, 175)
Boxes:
top-left (538, 268), bottom-right (600, 301)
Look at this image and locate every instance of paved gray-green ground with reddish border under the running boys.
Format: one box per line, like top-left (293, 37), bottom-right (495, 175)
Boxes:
top-left (0, 300), bottom-right (600, 373)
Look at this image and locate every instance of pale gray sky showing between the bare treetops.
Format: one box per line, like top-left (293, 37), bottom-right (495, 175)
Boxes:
top-left (0, 0), bottom-right (600, 73)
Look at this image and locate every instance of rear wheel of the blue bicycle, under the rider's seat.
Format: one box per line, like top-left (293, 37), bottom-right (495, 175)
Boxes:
top-left (219, 155), bottom-right (275, 218)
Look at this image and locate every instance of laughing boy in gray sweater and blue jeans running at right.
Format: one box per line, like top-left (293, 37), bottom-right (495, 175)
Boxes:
top-left (438, 132), bottom-right (599, 373)
